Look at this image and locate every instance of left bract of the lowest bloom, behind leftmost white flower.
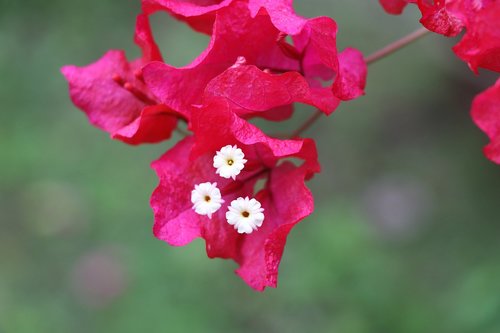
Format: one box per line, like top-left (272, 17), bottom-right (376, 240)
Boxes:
top-left (151, 137), bottom-right (237, 254)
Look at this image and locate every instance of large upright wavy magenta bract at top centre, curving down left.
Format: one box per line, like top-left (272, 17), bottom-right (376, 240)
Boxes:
top-left (144, 2), bottom-right (298, 112)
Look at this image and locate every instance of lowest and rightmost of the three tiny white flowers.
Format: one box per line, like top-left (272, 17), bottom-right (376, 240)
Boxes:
top-left (226, 197), bottom-right (264, 234)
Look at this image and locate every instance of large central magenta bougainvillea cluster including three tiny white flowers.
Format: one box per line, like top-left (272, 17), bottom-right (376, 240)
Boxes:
top-left (62, 0), bottom-right (366, 290)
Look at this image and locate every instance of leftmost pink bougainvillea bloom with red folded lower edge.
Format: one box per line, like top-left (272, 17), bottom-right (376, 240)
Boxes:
top-left (61, 15), bottom-right (178, 144)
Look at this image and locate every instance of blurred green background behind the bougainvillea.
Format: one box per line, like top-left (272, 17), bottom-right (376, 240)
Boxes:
top-left (0, 0), bottom-right (500, 333)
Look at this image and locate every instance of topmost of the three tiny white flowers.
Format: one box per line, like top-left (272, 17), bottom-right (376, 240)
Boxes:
top-left (214, 145), bottom-right (247, 180)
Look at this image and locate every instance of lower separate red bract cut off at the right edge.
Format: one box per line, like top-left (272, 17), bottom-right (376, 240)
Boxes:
top-left (472, 79), bottom-right (500, 164)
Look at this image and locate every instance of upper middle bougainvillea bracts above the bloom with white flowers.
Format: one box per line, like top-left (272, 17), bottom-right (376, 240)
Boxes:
top-left (144, 1), bottom-right (366, 119)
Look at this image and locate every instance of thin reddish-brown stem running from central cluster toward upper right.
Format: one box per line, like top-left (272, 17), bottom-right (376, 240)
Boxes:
top-left (290, 28), bottom-right (429, 138)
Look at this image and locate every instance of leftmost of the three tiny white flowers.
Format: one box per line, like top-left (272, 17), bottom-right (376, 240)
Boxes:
top-left (191, 183), bottom-right (224, 218)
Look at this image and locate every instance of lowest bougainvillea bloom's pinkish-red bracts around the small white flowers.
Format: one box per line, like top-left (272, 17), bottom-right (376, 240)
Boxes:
top-left (151, 99), bottom-right (319, 290)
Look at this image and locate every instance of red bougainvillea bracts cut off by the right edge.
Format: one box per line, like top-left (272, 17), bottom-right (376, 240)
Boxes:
top-left (379, 0), bottom-right (500, 164)
